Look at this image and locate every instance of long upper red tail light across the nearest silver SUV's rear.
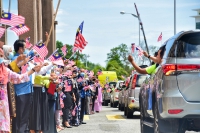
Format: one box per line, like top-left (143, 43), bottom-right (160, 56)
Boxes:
top-left (162, 64), bottom-right (200, 76)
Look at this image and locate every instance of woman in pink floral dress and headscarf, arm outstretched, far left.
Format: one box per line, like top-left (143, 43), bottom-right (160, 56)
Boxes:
top-left (0, 49), bottom-right (41, 133)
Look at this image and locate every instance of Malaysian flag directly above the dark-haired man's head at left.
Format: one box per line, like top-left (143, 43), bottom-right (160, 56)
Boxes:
top-left (10, 24), bottom-right (29, 36)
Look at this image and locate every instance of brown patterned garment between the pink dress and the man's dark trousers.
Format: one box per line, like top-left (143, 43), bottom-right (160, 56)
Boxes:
top-left (7, 82), bottom-right (16, 117)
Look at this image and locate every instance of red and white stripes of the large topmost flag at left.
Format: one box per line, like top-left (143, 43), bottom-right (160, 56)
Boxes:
top-left (0, 13), bottom-right (25, 26)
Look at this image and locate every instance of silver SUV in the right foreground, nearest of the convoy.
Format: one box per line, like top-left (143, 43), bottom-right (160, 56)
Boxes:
top-left (139, 31), bottom-right (200, 133)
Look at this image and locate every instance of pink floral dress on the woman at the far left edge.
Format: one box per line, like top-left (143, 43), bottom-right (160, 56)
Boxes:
top-left (0, 69), bottom-right (29, 133)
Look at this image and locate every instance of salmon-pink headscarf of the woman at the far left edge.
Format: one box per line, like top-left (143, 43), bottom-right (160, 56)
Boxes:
top-left (0, 48), bottom-right (8, 84)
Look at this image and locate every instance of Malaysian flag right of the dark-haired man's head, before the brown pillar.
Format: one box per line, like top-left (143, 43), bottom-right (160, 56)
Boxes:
top-left (32, 42), bottom-right (48, 58)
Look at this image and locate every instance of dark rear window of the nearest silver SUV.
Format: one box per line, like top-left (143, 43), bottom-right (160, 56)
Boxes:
top-left (177, 33), bottom-right (200, 58)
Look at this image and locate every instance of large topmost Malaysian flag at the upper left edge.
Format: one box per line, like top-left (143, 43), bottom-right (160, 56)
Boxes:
top-left (0, 12), bottom-right (25, 26)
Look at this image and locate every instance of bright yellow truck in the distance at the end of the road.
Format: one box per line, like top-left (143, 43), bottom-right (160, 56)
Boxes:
top-left (98, 71), bottom-right (118, 87)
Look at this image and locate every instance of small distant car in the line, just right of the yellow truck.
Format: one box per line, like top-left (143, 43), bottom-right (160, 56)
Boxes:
top-left (110, 80), bottom-right (124, 108)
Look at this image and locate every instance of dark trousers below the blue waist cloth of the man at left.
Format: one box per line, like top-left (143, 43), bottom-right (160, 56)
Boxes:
top-left (12, 93), bottom-right (32, 133)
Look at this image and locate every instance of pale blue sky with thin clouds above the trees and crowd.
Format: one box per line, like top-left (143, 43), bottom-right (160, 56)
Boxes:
top-left (4, 0), bottom-right (200, 66)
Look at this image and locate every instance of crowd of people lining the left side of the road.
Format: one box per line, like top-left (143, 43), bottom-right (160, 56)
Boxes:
top-left (0, 33), bottom-right (102, 133)
